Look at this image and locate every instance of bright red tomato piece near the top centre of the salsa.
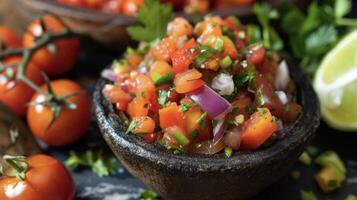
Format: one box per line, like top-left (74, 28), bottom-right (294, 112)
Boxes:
top-left (171, 39), bottom-right (199, 75)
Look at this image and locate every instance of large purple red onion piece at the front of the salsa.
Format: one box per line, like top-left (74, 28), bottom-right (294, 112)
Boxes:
top-left (188, 85), bottom-right (232, 119)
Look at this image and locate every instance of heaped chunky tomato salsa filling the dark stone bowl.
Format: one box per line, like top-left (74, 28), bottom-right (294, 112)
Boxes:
top-left (103, 16), bottom-right (301, 155)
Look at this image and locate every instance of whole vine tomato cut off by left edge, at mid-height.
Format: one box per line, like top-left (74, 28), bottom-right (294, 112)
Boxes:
top-left (0, 57), bottom-right (43, 116)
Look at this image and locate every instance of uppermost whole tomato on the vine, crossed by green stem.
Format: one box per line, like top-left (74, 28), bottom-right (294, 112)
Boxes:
top-left (23, 15), bottom-right (79, 77)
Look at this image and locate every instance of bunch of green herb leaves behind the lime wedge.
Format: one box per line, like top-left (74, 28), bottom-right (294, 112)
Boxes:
top-left (281, 0), bottom-right (357, 76)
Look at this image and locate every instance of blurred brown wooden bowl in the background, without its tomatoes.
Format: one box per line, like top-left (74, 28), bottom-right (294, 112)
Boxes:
top-left (0, 0), bottom-right (307, 49)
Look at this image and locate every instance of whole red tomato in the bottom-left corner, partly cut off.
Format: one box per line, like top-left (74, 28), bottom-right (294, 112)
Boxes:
top-left (0, 154), bottom-right (75, 200)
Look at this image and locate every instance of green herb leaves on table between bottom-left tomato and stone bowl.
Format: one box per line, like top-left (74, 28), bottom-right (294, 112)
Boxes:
top-left (66, 150), bottom-right (120, 177)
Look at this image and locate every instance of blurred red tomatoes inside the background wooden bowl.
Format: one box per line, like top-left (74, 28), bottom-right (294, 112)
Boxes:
top-left (57, 0), bottom-right (254, 16)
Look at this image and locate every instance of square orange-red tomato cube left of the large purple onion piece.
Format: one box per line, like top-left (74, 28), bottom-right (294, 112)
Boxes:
top-left (159, 103), bottom-right (186, 130)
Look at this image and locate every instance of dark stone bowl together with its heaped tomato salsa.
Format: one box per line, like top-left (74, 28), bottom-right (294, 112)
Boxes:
top-left (94, 14), bottom-right (319, 199)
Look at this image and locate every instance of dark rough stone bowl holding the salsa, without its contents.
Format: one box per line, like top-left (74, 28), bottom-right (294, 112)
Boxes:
top-left (94, 59), bottom-right (320, 200)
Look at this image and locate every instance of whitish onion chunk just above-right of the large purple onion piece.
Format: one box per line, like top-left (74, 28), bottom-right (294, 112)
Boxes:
top-left (212, 73), bottom-right (234, 95)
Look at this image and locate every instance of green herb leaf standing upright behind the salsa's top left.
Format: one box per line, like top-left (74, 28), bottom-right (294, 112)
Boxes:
top-left (127, 0), bottom-right (173, 42)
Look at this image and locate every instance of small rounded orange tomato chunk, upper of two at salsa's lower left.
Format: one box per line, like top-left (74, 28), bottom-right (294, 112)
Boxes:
top-left (128, 96), bottom-right (149, 117)
